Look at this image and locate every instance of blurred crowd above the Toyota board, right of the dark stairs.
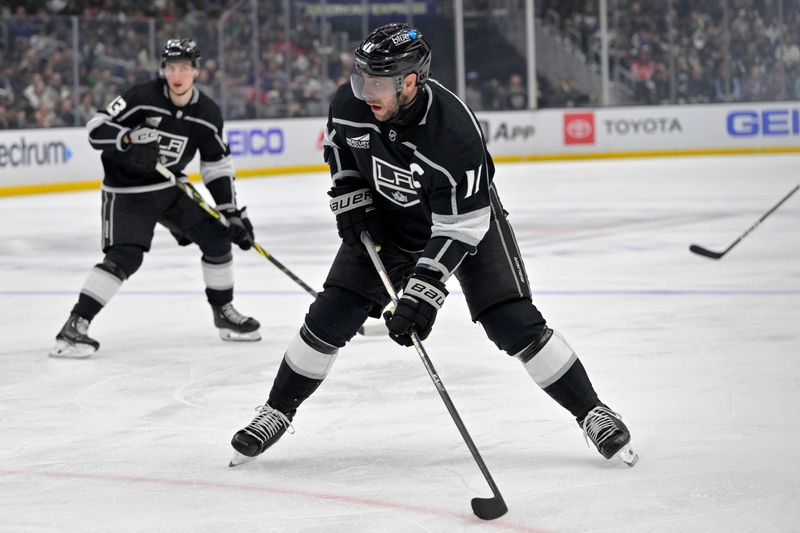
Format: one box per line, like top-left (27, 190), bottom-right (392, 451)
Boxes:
top-left (541, 0), bottom-right (800, 105)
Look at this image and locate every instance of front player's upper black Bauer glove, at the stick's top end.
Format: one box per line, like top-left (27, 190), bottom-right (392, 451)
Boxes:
top-left (328, 187), bottom-right (383, 246)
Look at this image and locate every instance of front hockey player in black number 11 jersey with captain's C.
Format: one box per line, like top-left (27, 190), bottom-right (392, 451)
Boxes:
top-left (231, 24), bottom-right (638, 466)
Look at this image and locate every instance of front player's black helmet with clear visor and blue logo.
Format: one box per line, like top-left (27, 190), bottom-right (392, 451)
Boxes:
top-left (354, 22), bottom-right (431, 92)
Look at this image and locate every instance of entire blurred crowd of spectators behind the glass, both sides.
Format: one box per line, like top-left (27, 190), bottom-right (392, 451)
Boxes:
top-left (0, 0), bottom-right (800, 129)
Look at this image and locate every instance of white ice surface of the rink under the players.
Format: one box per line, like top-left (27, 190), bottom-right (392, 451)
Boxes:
top-left (0, 156), bottom-right (800, 533)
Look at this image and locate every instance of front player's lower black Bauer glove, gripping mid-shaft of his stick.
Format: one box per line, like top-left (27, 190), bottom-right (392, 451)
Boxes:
top-left (383, 273), bottom-right (448, 346)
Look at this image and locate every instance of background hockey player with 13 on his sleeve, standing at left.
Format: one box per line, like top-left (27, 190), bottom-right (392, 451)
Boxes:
top-left (50, 39), bottom-right (261, 358)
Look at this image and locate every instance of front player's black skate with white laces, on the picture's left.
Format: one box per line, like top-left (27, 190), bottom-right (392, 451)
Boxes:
top-left (228, 403), bottom-right (296, 467)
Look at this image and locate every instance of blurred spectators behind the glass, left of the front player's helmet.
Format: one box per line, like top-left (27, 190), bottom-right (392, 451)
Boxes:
top-left (0, 0), bottom-right (351, 129)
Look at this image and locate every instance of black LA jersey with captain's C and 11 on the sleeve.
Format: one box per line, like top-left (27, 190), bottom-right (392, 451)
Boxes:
top-left (324, 80), bottom-right (494, 279)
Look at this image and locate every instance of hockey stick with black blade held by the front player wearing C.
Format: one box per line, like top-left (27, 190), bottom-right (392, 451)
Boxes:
top-left (361, 232), bottom-right (508, 520)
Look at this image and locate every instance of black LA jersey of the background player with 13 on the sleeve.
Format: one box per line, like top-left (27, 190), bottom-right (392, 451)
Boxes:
top-left (86, 79), bottom-right (235, 209)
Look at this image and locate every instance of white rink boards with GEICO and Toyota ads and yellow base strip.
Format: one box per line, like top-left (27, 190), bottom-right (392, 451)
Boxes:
top-left (0, 102), bottom-right (800, 196)
